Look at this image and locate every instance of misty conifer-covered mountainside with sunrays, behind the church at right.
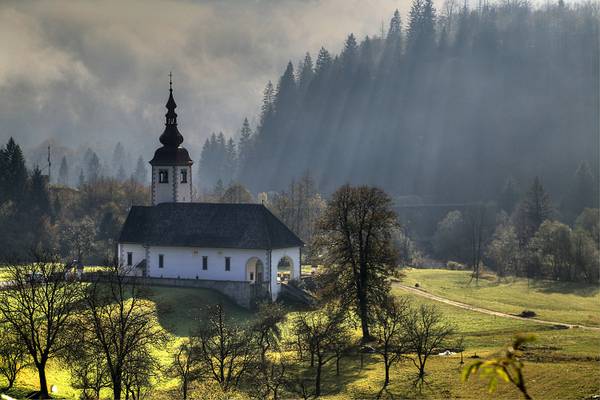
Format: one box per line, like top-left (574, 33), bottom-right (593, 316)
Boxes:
top-left (227, 0), bottom-right (600, 206)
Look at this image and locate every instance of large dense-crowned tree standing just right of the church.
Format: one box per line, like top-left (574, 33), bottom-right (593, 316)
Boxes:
top-left (316, 185), bottom-right (398, 340)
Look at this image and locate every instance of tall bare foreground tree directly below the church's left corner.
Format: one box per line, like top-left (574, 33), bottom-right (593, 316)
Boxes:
top-left (83, 265), bottom-right (166, 400)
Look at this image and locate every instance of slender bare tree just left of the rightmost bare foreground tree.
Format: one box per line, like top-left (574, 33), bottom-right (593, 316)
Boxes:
top-left (373, 297), bottom-right (410, 391)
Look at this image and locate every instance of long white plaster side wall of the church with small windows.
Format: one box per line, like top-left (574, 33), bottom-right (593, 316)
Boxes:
top-left (143, 246), bottom-right (266, 281)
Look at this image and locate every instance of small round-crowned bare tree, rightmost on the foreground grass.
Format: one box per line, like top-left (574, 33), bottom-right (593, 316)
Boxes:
top-left (404, 304), bottom-right (455, 385)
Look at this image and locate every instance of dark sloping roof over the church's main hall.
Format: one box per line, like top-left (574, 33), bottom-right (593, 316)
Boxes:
top-left (119, 203), bottom-right (304, 250)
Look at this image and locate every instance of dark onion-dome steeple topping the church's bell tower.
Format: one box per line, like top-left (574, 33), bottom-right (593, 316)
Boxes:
top-left (150, 73), bottom-right (192, 165)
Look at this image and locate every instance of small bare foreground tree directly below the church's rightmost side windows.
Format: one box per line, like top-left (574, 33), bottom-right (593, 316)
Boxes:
top-left (197, 304), bottom-right (257, 391)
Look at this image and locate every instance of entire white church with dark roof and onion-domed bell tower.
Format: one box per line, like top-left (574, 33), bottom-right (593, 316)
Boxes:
top-left (117, 77), bottom-right (303, 305)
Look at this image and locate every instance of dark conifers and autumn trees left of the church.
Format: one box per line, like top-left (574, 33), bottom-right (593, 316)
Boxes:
top-left (0, 138), bottom-right (149, 263)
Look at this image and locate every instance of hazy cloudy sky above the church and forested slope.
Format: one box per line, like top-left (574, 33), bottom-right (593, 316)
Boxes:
top-left (0, 0), bottom-right (410, 159)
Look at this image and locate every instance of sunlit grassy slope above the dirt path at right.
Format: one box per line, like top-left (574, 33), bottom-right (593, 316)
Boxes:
top-left (402, 269), bottom-right (600, 326)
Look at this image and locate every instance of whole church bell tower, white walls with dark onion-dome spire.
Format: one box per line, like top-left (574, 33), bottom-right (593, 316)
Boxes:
top-left (150, 74), bottom-right (193, 205)
